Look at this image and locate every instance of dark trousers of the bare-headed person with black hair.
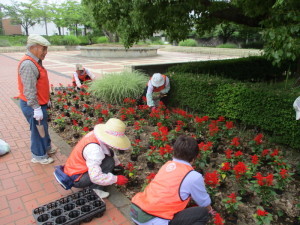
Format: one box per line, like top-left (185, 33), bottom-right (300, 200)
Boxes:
top-left (169, 207), bottom-right (209, 225)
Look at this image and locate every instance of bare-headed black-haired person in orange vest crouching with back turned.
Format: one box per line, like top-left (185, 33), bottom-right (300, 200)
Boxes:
top-left (130, 135), bottom-right (215, 225)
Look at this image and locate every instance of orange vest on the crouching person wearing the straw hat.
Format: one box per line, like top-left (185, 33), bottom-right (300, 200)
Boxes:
top-left (64, 131), bottom-right (100, 180)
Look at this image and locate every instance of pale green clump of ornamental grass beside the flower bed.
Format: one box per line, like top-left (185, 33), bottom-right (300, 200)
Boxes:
top-left (88, 71), bottom-right (149, 104)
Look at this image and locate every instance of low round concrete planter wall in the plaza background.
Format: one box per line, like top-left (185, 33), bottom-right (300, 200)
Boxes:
top-left (80, 46), bottom-right (158, 58)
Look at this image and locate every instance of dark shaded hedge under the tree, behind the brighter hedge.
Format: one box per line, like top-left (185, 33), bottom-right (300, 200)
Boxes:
top-left (168, 56), bottom-right (296, 82)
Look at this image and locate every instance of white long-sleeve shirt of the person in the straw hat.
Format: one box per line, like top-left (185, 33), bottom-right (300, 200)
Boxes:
top-left (83, 143), bottom-right (120, 186)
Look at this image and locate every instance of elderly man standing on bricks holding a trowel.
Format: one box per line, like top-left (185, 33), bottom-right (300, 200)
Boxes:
top-left (18, 34), bottom-right (55, 164)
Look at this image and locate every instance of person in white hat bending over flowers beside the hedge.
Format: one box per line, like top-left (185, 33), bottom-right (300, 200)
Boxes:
top-left (143, 73), bottom-right (171, 109)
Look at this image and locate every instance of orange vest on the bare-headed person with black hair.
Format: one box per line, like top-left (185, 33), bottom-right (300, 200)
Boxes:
top-left (132, 161), bottom-right (193, 220)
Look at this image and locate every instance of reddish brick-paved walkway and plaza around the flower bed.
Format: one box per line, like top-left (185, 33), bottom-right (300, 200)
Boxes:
top-left (0, 51), bottom-right (238, 225)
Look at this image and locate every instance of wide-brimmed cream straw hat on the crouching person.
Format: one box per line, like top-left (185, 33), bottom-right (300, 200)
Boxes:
top-left (94, 118), bottom-right (131, 150)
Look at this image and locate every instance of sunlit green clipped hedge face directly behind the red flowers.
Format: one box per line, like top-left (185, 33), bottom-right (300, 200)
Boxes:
top-left (169, 73), bottom-right (300, 148)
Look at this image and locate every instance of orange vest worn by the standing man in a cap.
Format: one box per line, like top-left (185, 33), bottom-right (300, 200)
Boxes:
top-left (18, 55), bottom-right (50, 105)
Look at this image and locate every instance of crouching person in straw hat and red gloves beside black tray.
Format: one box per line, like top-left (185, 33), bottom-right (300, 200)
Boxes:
top-left (54, 118), bottom-right (131, 198)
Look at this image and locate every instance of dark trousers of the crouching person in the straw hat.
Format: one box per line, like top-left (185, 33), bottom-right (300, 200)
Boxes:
top-left (73, 155), bottom-right (115, 190)
